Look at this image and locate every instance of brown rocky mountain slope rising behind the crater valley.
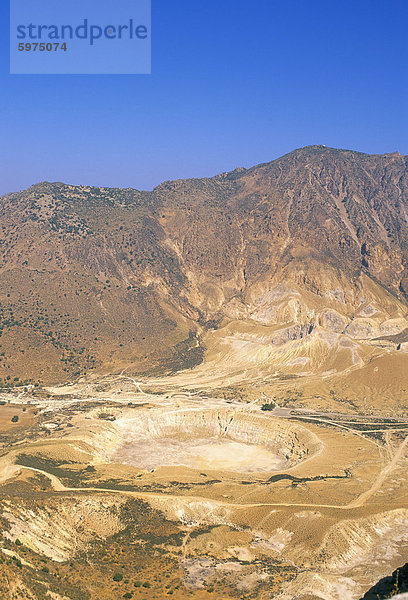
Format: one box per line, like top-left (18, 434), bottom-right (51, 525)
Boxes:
top-left (0, 146), bottom-right (408, 402)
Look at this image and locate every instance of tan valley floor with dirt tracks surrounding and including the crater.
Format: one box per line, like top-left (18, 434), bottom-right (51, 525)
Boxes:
top-left (0, 380), bottom-right (408, 600)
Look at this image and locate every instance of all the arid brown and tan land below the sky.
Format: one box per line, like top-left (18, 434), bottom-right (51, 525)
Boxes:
top-left (0, 146), bottom-right (408, 600)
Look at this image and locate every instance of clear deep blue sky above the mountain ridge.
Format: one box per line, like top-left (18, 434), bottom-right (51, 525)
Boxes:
top-left (0, 0), bottom-right (408, 193)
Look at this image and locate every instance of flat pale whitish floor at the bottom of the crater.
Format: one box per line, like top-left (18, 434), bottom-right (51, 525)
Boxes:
top-left (112, 437), bottom-right (286, 473)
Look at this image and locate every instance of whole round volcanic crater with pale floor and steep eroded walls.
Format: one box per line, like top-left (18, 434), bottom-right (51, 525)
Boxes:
top-left (110, 409), bottom-right (320, 473)
